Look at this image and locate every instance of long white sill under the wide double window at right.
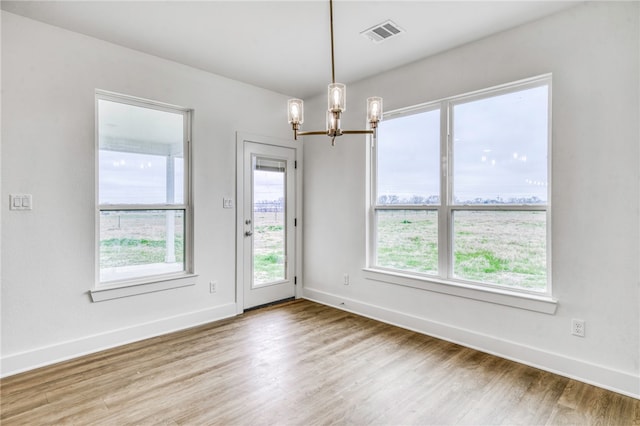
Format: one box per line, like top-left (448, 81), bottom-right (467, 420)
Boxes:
top-left (363, 268), bottom-right (558, 315)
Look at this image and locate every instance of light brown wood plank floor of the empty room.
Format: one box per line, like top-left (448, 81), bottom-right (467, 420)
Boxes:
top-left (0, 300), bottom-right (640, 426)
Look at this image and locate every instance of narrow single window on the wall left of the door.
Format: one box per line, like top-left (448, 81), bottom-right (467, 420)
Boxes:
top-left (96, 93), bottom-right (191, 284)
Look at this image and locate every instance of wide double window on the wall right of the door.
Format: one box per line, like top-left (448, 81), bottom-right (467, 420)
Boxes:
top-left (370, 76), bottom-right (551, 294)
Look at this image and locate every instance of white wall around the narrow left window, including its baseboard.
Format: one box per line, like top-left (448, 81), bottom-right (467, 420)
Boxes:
top-left (1, 12), bottom-right (290, 375)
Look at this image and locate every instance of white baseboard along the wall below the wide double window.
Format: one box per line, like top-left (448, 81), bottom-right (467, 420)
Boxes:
top-left (304, 287), bottom-right (640, 399)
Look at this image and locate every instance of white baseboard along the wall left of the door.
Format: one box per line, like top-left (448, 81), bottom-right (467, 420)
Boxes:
top-left (0, 303), bottom-right (236, 377)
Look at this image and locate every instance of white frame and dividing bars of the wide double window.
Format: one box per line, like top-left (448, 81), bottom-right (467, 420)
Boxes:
top-left (364, 74), bottom-right (555, 300)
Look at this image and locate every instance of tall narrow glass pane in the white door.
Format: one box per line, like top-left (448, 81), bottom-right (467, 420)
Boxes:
top-left (253, 157), bottom-right (287, 286)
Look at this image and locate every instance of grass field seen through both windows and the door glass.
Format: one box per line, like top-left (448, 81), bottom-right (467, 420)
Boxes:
top-left (100, 210), bottom-right (547, 290)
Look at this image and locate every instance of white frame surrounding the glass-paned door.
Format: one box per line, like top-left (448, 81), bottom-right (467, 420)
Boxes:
top-left (236, 132), bottom-right (303, 314)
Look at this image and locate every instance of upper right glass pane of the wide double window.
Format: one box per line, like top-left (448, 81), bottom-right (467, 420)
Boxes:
top-left (453, 85), bottom-right (549, 204)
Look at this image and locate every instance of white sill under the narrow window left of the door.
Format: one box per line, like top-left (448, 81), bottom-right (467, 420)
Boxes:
top-left (89, 274), bottom-right (198, 302)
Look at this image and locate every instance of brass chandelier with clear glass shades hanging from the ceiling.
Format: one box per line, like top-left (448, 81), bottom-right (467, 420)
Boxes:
top-left (287, 0), bottom-right (382, 146)
